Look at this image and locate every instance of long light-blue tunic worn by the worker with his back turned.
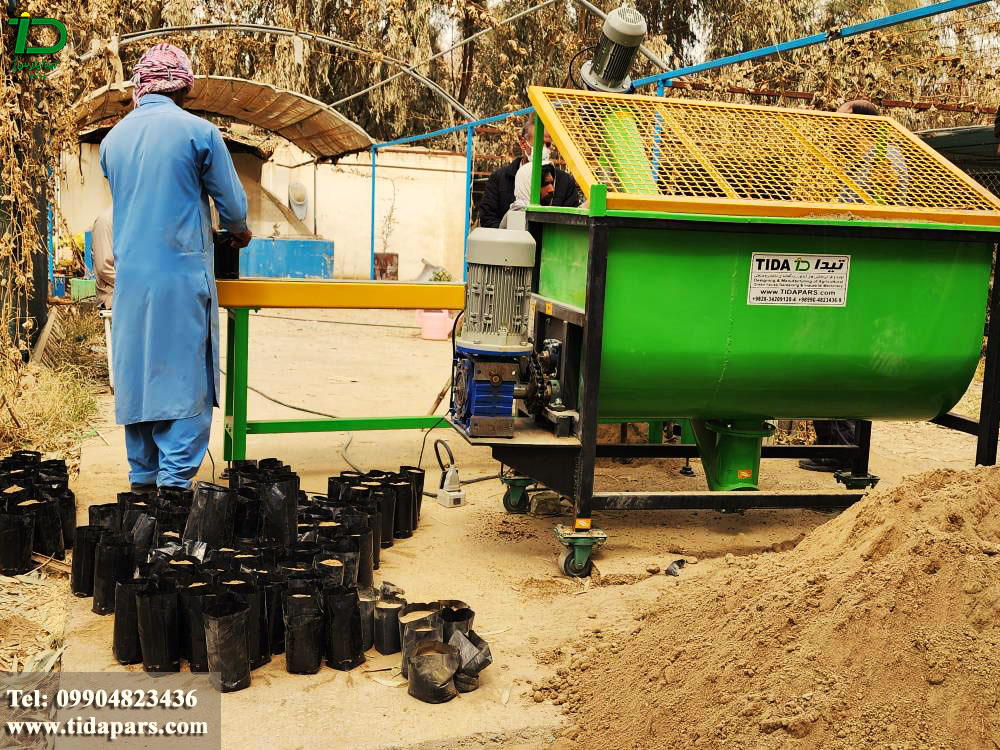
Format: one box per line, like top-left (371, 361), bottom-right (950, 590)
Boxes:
top-left (101, 94), bottom-right (247, 424)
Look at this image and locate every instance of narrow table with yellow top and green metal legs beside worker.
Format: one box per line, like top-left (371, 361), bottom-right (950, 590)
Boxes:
top-left (217, 279), bottom-right (465, 461)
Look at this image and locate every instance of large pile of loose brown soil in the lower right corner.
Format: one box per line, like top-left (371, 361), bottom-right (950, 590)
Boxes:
top-left (533, 468), bottom-right (1000, 750)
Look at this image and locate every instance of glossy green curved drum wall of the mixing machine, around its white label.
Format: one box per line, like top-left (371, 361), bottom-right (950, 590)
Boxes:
top-left (542, 224), bottom-right (992, 419)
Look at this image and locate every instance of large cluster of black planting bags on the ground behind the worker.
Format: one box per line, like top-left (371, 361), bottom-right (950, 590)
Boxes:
top-left (71, 459), bottom-right (488, 699)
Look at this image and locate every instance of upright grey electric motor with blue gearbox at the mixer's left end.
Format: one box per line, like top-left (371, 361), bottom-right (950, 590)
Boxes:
top-left (452, 227), bottom-right (535, 437)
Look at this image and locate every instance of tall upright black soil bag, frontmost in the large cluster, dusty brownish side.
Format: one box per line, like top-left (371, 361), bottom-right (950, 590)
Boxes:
top-left (202, 596), bottom-right (250, 693)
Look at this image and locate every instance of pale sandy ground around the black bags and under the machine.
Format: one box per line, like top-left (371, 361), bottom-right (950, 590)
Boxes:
top-left (63, 310), bottom-right (975, 750)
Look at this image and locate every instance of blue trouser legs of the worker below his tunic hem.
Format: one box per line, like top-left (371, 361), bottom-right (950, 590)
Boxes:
top-left (125, 407), bottom-right (212, 488)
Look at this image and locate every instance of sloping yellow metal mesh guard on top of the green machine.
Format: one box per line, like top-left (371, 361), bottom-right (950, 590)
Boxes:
top-left (528, 87), bottom-right (1000, 226)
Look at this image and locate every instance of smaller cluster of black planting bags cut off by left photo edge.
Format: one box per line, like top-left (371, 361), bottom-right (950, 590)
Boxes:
top-left (0, 451), bottom-right (76, 576)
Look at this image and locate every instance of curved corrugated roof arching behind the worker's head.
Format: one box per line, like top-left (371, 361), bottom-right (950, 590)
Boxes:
top-left (77, 76), bottom-right (373, 158)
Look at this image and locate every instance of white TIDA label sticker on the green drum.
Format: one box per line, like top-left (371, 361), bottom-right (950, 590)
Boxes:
top-left (747, 253), bottom-right (851, 307)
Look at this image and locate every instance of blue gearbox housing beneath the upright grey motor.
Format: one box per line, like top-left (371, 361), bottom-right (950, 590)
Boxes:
top-left (452, 346), bottom-right (524, 437)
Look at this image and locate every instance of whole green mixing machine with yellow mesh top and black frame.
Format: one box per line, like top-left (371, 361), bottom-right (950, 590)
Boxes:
top-left (451, 88), bottom-right (1000, 576)
